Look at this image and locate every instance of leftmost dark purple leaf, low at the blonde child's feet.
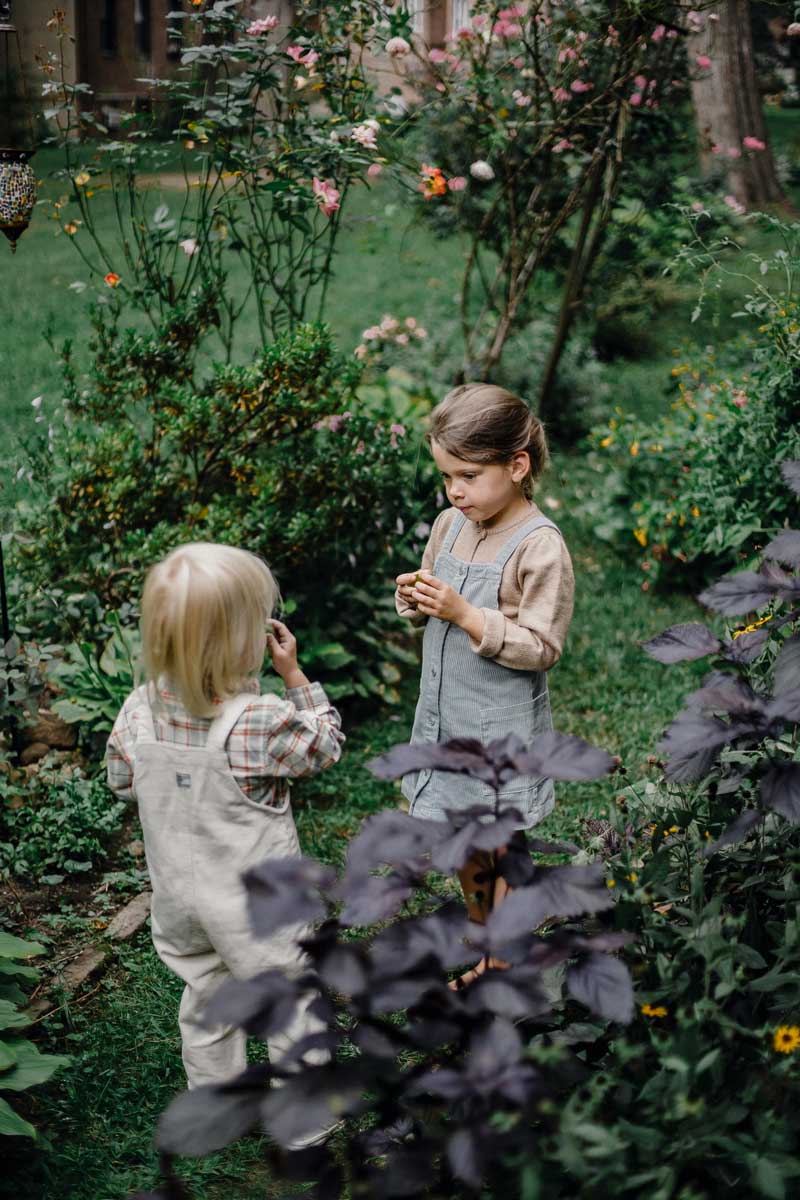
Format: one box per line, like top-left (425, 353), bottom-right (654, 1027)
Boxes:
top-left (156, 1066), bottom-right (270, 1157)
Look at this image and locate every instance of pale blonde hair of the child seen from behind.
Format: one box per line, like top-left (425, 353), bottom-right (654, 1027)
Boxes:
top-left (142, 541), bottom-right (279, 716)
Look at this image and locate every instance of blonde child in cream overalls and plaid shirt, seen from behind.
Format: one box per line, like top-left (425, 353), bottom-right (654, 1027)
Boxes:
top-left (108, 542), bottom-right (343, 1087)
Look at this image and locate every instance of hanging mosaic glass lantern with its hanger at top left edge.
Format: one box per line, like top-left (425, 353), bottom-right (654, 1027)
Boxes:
top-left (0, 0), bottom-right (36, 253)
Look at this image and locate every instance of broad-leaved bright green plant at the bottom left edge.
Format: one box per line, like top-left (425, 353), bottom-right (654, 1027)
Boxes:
top-left (0, 930), bottom-right (70, 1138)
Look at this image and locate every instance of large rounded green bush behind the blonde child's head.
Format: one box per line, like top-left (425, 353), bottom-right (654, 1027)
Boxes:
top-left (14, 319), bottom-right (429, 705)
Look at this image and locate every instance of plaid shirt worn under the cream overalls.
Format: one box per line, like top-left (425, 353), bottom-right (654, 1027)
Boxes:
top-left (107, 679), bottom-right (344, 808)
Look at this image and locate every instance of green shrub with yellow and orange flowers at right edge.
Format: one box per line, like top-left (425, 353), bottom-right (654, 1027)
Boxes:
top-left (588, 224), bottom-right (800, 585)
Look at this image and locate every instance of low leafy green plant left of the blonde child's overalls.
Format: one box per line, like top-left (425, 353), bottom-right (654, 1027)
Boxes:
top-left (0, 774), bottom-right (127, 878)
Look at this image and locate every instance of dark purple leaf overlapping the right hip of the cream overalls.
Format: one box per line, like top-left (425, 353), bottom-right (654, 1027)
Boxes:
top-left (243, 858), bottom-right (336, 937)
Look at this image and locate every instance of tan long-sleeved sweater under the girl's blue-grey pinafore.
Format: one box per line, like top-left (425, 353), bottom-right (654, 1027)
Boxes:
top-left (395, 504), bottom-right (575, 671)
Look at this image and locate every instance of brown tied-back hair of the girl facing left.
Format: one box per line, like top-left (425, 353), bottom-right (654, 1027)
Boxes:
top-left (428, 383), bottom-right (549, 499)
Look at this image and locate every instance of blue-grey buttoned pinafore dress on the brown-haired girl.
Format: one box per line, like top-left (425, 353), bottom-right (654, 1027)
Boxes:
top-left (403, 512), bottom-right (558, 829)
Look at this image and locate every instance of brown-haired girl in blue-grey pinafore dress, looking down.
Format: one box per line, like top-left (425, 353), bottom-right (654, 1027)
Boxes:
top-left (396, 383), bottom-right (573, 982)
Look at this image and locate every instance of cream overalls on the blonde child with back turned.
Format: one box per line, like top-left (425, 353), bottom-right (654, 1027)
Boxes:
top-left (133, 689), bottom-right (320, 1087)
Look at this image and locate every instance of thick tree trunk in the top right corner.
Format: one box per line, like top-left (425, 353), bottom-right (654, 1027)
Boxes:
top-left (686, 0), bottom-right (792, 211)
